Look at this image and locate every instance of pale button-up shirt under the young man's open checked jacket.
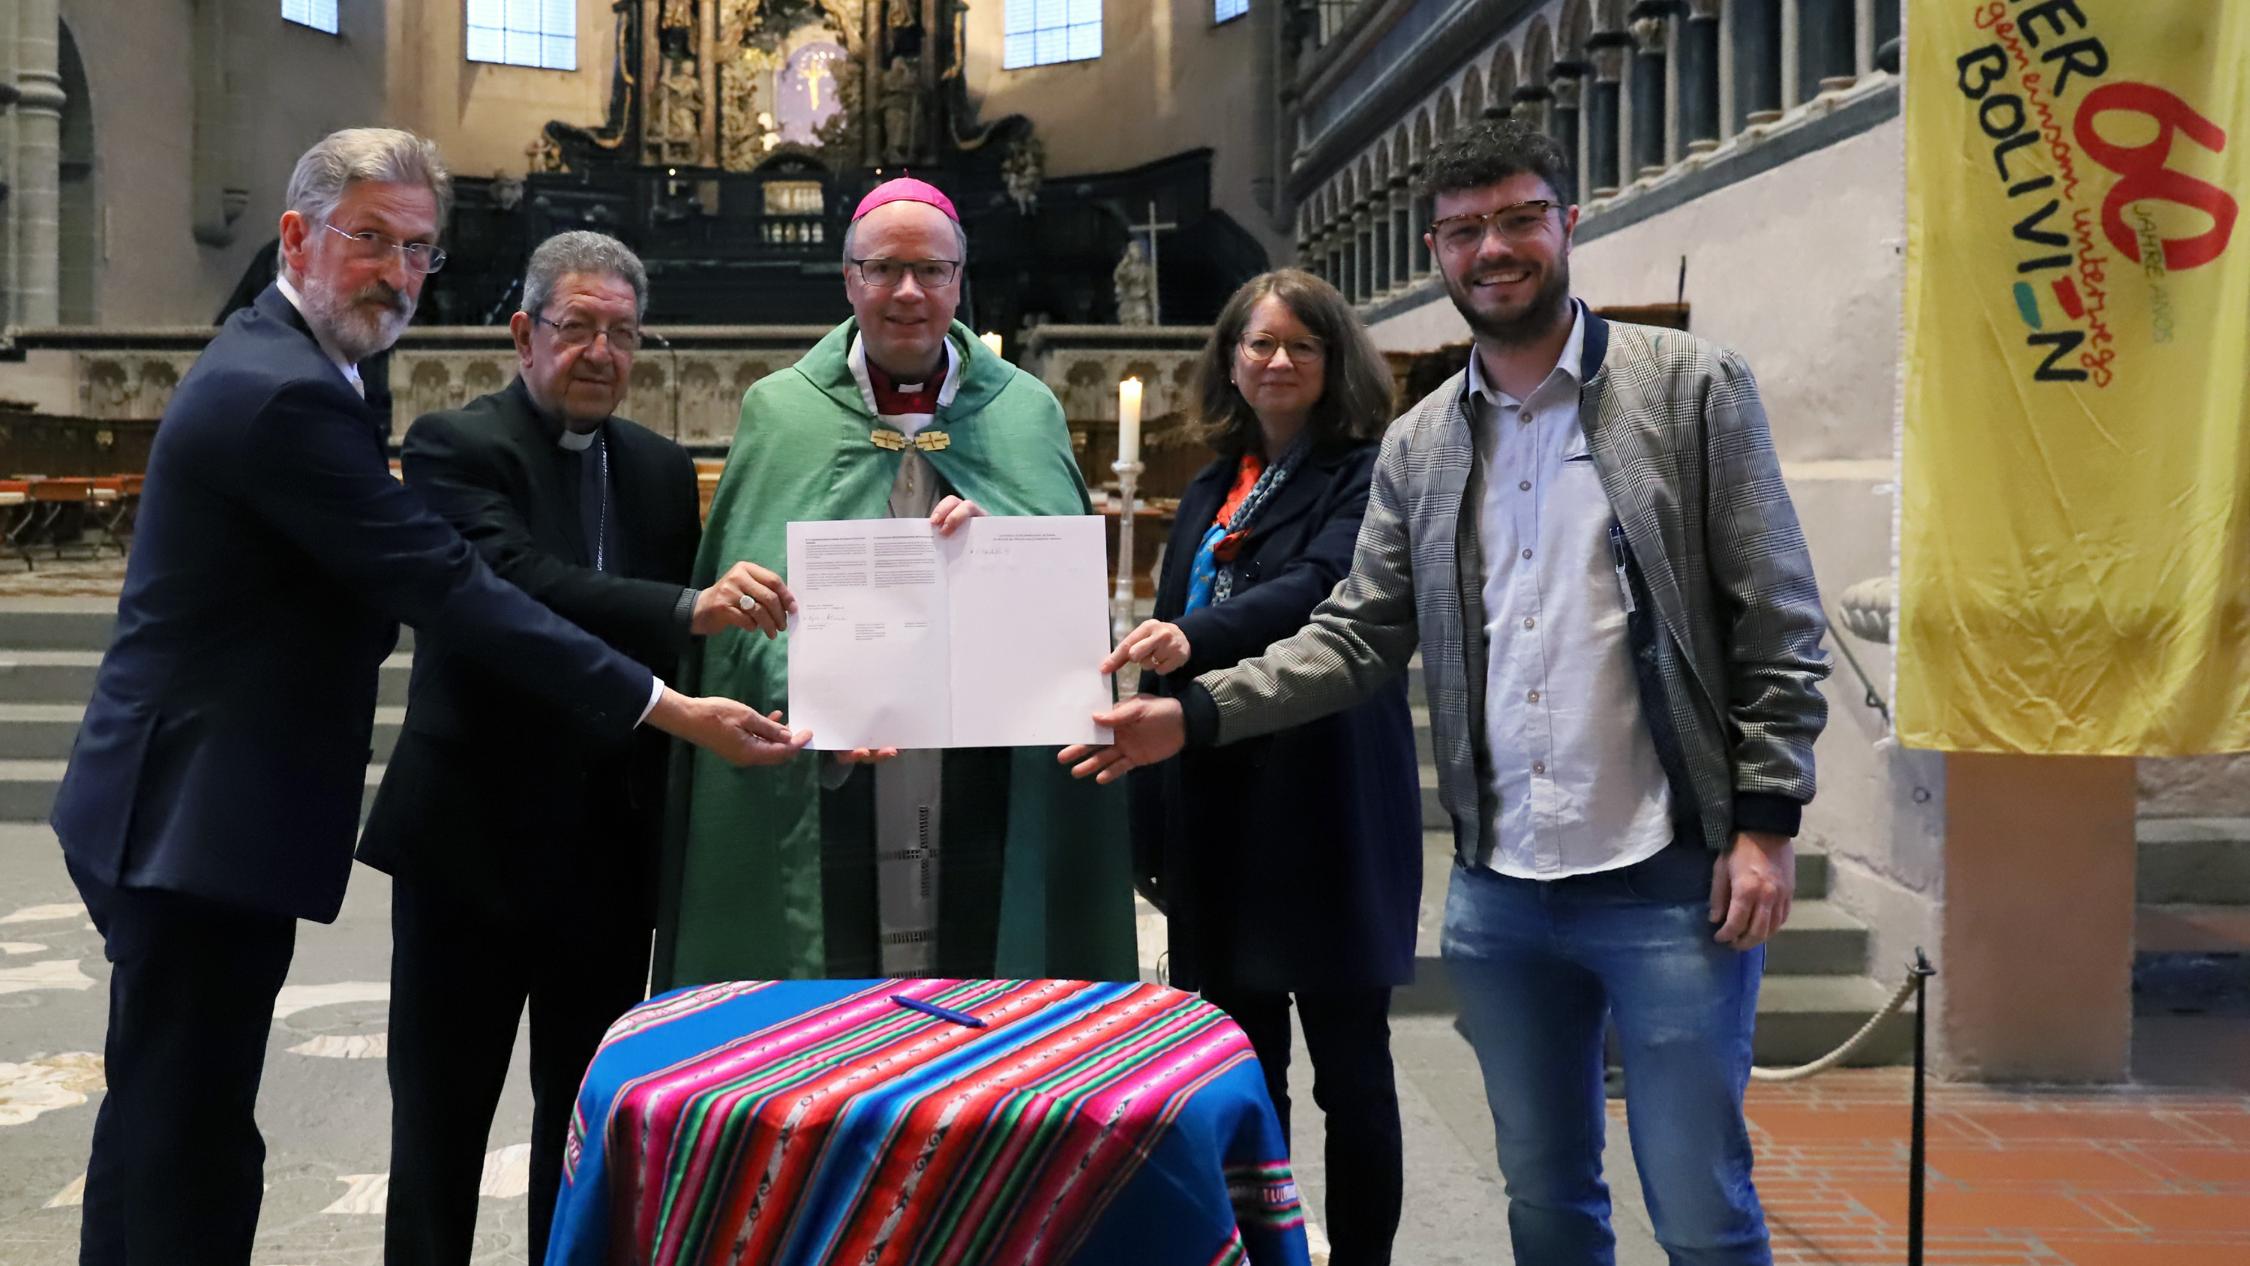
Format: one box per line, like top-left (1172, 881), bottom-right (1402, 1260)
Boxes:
top-left (1469, 308), bottom-right (1672, 879)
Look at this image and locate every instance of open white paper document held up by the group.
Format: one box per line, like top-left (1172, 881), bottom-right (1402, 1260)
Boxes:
top-left (788, 515), bottom-right (1109, 751)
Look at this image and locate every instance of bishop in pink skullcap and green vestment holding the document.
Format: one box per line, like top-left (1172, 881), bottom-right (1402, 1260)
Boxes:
top-left (657, 180), bottom-right (1136, 987)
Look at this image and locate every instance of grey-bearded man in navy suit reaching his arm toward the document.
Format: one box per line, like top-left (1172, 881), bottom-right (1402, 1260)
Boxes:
top-left (54, 128), bottom-right (803, 1266)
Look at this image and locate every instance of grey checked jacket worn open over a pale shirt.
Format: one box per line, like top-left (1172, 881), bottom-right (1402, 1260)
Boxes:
top-left (1181, 301), bottom-right (1829, 866)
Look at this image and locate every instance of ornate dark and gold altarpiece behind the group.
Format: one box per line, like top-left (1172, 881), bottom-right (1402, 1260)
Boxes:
top-left (409, 0), bottom-right (1267, 346)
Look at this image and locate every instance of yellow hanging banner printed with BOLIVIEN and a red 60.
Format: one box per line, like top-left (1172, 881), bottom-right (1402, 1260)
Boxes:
top-left (1897, 0), bottom-right (2250, 756)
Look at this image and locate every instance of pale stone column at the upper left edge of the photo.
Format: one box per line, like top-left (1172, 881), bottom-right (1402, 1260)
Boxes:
top-left (7, 0), bottom-right (63, 326)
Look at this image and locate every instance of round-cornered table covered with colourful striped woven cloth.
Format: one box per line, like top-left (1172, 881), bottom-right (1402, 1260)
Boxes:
top-left (547, 980), bottom-right (1307, 1266)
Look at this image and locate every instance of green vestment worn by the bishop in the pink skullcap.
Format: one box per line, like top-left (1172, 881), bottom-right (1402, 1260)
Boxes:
top-left (655, 322), bottom-right (1139, 989)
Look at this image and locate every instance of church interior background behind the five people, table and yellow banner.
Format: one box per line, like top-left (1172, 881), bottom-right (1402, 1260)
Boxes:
top-left (0, 0), bottom-right (2250, 1266)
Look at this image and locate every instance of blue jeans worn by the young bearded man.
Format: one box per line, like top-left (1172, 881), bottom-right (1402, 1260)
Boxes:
top-left (1445, 848), bottom-right (1773, 1266)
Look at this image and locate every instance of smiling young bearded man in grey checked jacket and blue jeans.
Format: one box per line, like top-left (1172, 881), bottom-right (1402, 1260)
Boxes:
top-left (1062, 121), bottom-right (1827, 1266)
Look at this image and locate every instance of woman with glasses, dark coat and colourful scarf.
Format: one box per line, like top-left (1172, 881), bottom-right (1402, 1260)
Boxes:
top-left (1114, 270), bottom-right (1422, 1266)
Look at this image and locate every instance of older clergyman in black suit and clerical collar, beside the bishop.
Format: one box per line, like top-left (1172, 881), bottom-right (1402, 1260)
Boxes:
top-left (360, 232), bottom-right (788, 1266)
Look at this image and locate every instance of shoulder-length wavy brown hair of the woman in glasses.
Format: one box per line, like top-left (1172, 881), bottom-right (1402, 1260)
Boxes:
top-left (1195, 268), bottom-right (1393, 456)
